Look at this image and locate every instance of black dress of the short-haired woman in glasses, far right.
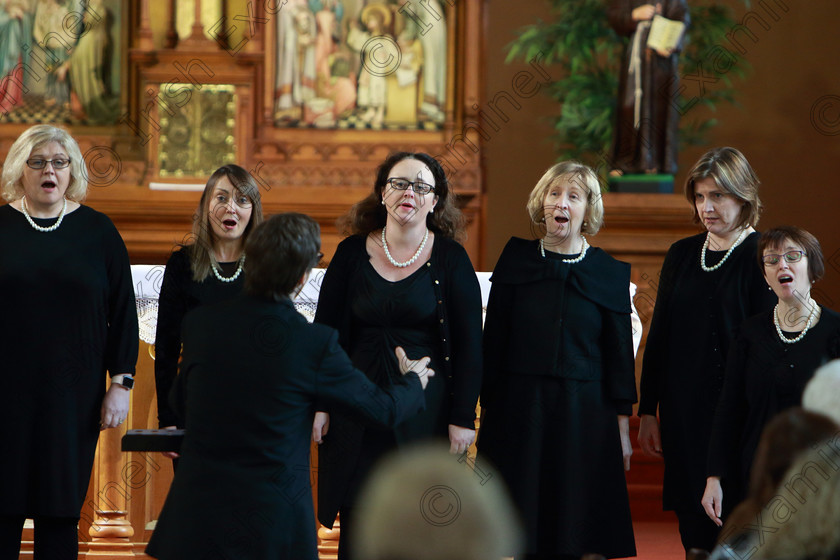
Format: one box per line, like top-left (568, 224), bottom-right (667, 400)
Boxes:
top-left (708, 307), bottom-right (840, 507)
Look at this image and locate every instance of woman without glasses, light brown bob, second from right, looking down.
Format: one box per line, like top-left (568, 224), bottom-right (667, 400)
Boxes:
top-left (638, 148), bottom-right (775, 551)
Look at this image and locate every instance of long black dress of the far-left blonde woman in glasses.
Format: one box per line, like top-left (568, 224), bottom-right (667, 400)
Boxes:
top-left (0, 205), bottom-right (139, 517)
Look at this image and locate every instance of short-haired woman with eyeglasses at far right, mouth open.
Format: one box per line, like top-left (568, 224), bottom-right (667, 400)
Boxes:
top-left (702, 226), bottom-right (840, 526)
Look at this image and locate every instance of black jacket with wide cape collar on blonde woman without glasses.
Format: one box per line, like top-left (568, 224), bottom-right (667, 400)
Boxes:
top-left (481, 237), bottom-right (636, 415)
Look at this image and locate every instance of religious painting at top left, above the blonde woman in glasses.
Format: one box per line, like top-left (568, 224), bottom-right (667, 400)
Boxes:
top-left (0, 0), bottom-right (124, 125)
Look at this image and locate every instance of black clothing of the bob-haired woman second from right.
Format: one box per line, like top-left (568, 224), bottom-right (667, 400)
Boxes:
top-left (639, 232), bottom-right (777, 513)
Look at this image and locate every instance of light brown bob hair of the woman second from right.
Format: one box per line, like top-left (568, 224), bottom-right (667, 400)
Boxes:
top-left (685, 147), bottom-right (764, 231)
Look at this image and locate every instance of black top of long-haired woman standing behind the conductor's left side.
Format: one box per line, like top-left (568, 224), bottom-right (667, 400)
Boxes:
top-left (155, 245), bottom-right (245, 428)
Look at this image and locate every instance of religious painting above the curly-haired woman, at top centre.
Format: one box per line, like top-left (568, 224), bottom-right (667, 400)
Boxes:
top-left (274, 0), bottom-right (454, 130)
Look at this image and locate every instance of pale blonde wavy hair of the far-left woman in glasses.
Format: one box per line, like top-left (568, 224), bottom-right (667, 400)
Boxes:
top-left (0, 124), bottom-right (87, 202)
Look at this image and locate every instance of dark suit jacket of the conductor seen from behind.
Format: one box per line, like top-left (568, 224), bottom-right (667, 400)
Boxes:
top-left (147, 296), bottom-right (425, 560)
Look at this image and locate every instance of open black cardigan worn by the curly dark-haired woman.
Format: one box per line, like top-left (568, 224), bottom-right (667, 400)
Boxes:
top-left (315, 235), bottom-right (482, 429)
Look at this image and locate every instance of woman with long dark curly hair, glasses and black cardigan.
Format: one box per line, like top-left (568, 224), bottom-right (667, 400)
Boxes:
top-left (312, 152), bottom-right (481, 559)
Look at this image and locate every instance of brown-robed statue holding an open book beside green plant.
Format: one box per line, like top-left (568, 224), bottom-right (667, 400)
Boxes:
top-left (607, 0), bottom-right (689, 176)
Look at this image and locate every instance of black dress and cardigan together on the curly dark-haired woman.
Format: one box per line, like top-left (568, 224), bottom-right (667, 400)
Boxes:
top-left (315, 236), bottom-right (481, 538)
